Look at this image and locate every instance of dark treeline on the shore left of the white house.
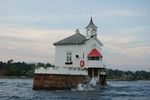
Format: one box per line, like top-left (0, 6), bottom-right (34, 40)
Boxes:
top-left (0, 60), bottom-right (54, 77)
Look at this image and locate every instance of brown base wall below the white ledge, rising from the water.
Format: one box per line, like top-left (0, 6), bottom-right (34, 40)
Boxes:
top-left (33, 74), bottom-right (88, 90)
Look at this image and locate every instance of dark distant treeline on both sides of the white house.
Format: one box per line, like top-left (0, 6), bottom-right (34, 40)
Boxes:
top-left (0, 60), bottom-right (150, 80)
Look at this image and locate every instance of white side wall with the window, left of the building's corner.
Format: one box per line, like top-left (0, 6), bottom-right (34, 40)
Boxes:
top-left (55, 45), bottom-right (83, 67)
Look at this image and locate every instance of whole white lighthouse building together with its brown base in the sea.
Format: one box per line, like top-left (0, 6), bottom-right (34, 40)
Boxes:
top-left (33, 17), bottom-right (106, 89)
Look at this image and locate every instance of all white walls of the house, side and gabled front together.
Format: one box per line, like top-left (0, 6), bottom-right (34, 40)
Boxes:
top-left (55, 38), bottom-right (103, 68)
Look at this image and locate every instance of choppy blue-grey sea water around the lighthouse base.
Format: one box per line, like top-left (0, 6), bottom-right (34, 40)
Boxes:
top-left (0, 79), bottom-right (150, 100)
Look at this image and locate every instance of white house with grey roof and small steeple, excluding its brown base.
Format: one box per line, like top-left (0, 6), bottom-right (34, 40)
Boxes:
top-left (54, 18), bottom-right (104, 75)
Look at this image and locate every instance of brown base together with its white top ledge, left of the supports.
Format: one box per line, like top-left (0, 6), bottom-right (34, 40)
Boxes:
top-left (33, 67), bottom-right (88, 90)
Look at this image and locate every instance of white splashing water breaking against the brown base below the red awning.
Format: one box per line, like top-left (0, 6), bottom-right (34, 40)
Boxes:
top-left (71, 77), bottom-right (98, 91)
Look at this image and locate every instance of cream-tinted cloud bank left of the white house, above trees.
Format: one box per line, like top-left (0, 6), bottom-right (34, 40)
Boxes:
top-left (0, 27), bottom-right (74, 63)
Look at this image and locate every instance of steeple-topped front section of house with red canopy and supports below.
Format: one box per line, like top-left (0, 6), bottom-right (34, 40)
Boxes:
top-left (85, 17), bottom-right (107, 85)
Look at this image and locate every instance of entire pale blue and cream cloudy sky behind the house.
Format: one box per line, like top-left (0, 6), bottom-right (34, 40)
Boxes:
top-left (0, 0), bottom-right (150, 71)
